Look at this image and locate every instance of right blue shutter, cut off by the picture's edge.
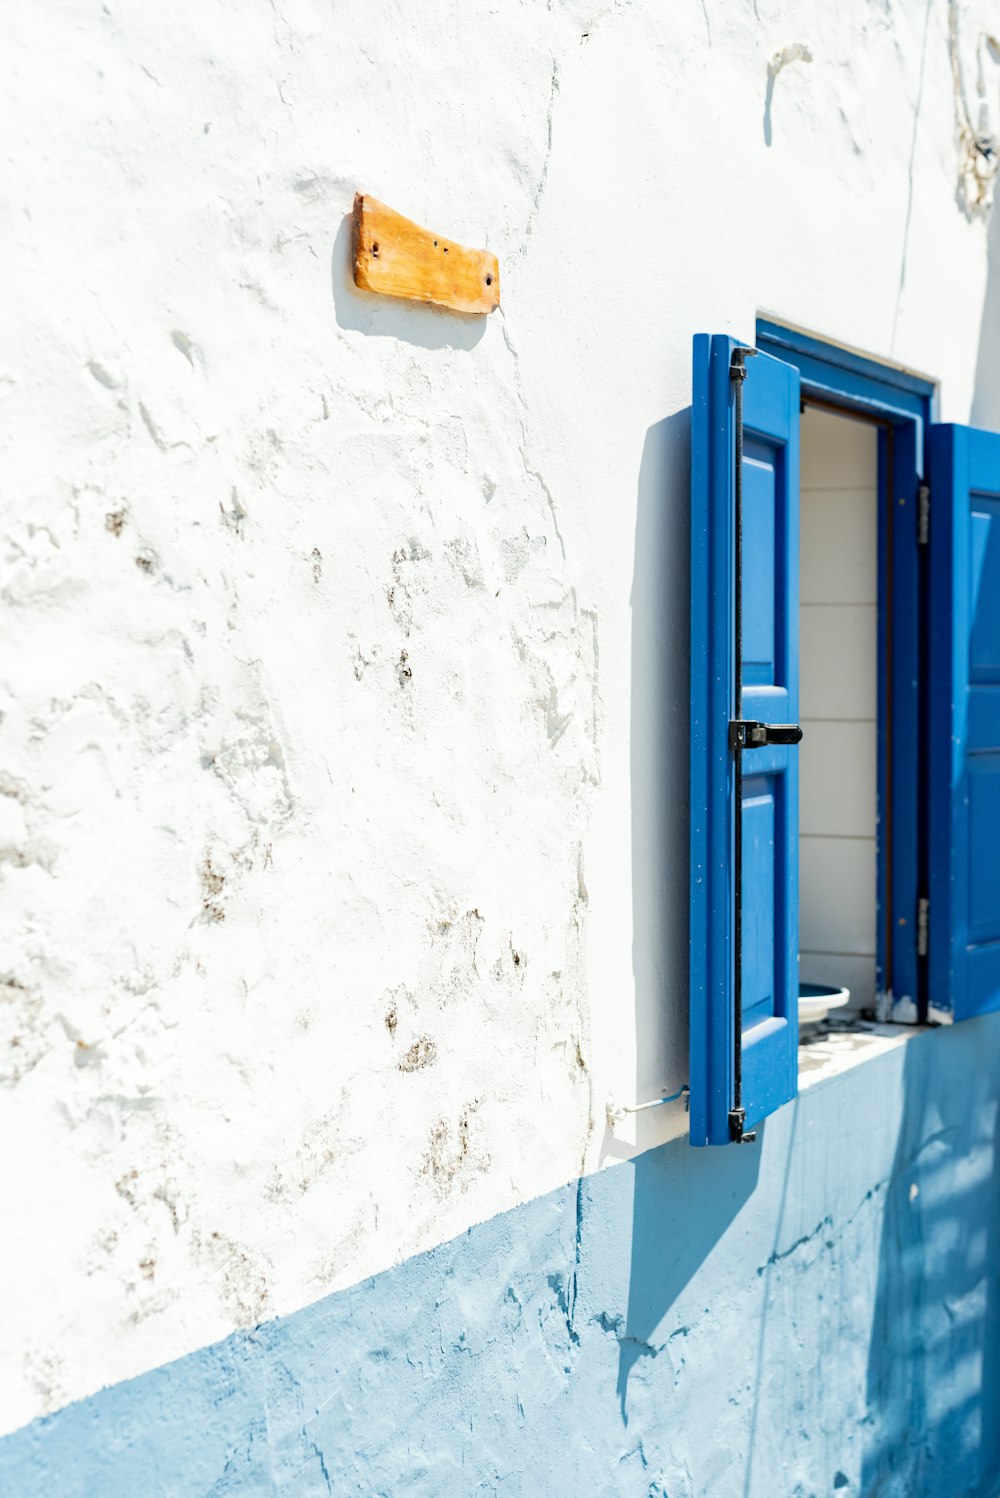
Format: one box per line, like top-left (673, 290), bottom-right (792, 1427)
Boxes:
top-left (928, 425), bottom-right (1000, 1020)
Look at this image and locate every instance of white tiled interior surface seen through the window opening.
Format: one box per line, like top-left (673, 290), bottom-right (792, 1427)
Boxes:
top-left (799, 406), bottom-right (879, 1010)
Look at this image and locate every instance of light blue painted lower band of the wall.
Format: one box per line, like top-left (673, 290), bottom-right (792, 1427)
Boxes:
top-left (0, 1019), bottom-right (1000, 1498)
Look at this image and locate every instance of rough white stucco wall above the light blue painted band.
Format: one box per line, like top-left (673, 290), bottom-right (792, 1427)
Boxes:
top-left (0, 0), bottom-right (1000, 1429)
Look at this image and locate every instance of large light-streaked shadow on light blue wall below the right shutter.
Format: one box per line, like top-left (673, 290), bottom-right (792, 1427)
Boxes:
top-left (861, 1020), bottom-right (1000, 1498)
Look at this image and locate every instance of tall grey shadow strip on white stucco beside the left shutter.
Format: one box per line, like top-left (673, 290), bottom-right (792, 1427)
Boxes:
top-left (629, 407), bottom-right (690, 1141)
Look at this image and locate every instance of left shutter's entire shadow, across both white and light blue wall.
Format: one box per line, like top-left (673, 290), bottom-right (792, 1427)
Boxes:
top-left (615, 406), bottom-right (760, 1425)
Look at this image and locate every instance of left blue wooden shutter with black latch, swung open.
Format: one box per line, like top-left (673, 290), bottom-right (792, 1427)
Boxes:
top-left (690, 334), bottom-right (799, 1144)
